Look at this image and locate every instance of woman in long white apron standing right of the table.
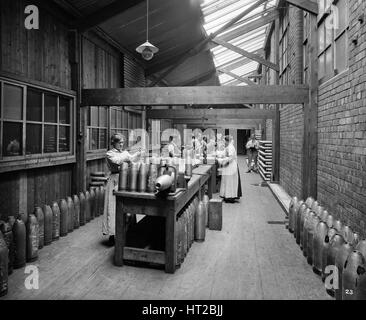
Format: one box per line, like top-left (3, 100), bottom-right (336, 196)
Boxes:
top-left (219, 136), bottom-right (242, 203)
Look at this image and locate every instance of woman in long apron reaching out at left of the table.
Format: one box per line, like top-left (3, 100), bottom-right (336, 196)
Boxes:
top-left (102, 133), bottom-right (141, 246)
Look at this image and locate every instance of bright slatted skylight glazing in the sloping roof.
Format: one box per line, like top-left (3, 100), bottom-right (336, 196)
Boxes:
top-left (201, 0), bottom-right (278, 85)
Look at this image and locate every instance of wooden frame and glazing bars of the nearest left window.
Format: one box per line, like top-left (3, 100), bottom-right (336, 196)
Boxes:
top-left (0, 76), bottom-right (76, 164)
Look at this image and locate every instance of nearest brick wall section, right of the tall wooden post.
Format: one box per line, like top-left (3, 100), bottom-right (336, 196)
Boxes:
top-left (317, 0), bottom-right (366, 236)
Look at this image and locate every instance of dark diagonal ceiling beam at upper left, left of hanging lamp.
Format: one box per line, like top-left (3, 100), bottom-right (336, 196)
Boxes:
top-left (75, 0), bottom-right (145, 32)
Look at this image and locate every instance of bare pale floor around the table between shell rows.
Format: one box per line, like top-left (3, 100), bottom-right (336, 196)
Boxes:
top-left (2, 157), bottom-right (332, 300)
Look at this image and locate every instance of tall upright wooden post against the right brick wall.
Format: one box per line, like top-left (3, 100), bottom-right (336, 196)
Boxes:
top-left (302, 14), bottom-right (318, 199)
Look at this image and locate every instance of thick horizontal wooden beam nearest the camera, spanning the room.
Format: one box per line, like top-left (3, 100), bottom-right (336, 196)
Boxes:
top-left (82, 85), bottom-right (309, 106)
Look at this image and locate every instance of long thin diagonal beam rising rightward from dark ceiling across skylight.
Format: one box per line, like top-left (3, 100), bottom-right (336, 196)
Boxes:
top-left (150, 0), bottom-right (267, 87)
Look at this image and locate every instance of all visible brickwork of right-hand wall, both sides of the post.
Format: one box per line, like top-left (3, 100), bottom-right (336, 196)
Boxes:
top-left (267, 0), bottom-right (366, 236)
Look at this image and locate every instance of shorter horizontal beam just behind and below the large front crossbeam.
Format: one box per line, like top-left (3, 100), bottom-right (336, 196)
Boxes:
top-left (146, 108), bottom-right (275, 122)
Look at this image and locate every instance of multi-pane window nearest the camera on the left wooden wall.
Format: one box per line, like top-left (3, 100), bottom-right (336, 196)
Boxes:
top-left (0, 80), bottom-right (74, 158)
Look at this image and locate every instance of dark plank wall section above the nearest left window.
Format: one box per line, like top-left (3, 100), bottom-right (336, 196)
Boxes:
top-left (0, 0), bottom-right (71, 89)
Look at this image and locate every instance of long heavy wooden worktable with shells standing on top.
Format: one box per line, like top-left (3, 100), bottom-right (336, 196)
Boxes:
top-left (114, 165), bottom-right (216, 273)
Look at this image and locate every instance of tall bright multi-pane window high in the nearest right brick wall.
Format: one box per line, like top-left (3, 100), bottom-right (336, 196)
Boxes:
top-left (318, 0), bottom-right (349, 81)
